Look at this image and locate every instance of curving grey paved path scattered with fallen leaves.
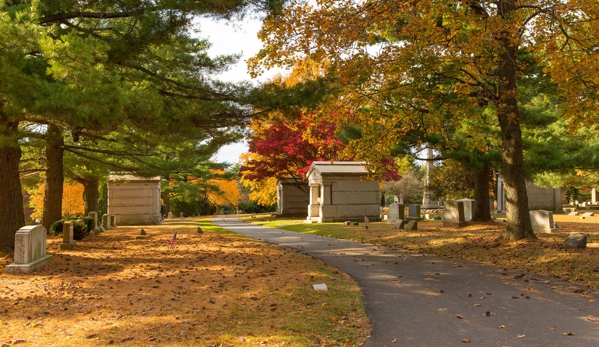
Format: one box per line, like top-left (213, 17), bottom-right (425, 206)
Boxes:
top-left (213, 217), bottom-right (599, 347)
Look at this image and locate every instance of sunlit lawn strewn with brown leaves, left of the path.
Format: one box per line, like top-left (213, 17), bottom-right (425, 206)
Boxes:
top-left (0, 220), bottom-right (370, 346)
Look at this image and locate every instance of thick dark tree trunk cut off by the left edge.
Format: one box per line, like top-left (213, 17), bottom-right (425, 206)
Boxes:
top-left (0, 122), bottom-right (25, 255)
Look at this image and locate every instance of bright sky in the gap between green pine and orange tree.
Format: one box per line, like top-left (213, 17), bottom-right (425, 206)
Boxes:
top-left (200, 19), bottom-right (277, 164)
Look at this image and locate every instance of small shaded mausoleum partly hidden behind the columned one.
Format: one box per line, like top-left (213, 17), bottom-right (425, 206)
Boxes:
top-left (277, 178), bottom-right (310, 217)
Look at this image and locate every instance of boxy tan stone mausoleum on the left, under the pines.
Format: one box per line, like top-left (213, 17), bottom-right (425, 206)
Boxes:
top-left (108, 174), bottom-right (161, 225)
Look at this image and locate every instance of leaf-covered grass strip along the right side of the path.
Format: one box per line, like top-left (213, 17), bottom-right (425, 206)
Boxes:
top-left (248, 214), bottom-right (599, 289)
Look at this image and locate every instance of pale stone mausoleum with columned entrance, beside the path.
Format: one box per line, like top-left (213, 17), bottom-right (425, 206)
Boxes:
top-left (306, 161), bottom-right (380, 223)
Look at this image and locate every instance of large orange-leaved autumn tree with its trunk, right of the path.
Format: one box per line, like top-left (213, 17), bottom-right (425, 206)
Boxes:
top-left (250, 0), bottom-right (599, 240)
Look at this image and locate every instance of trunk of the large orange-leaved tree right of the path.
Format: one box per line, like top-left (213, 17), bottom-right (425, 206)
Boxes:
top-left (497, 0), bottom-right (537, 240)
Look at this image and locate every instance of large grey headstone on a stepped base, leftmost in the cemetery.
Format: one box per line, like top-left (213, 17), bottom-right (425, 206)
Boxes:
top-left (4, 225), bottom-right (52, 273)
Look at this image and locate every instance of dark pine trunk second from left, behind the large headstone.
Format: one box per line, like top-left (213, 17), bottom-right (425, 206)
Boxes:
top-left (42, 124), bottom-right (64, 234)
